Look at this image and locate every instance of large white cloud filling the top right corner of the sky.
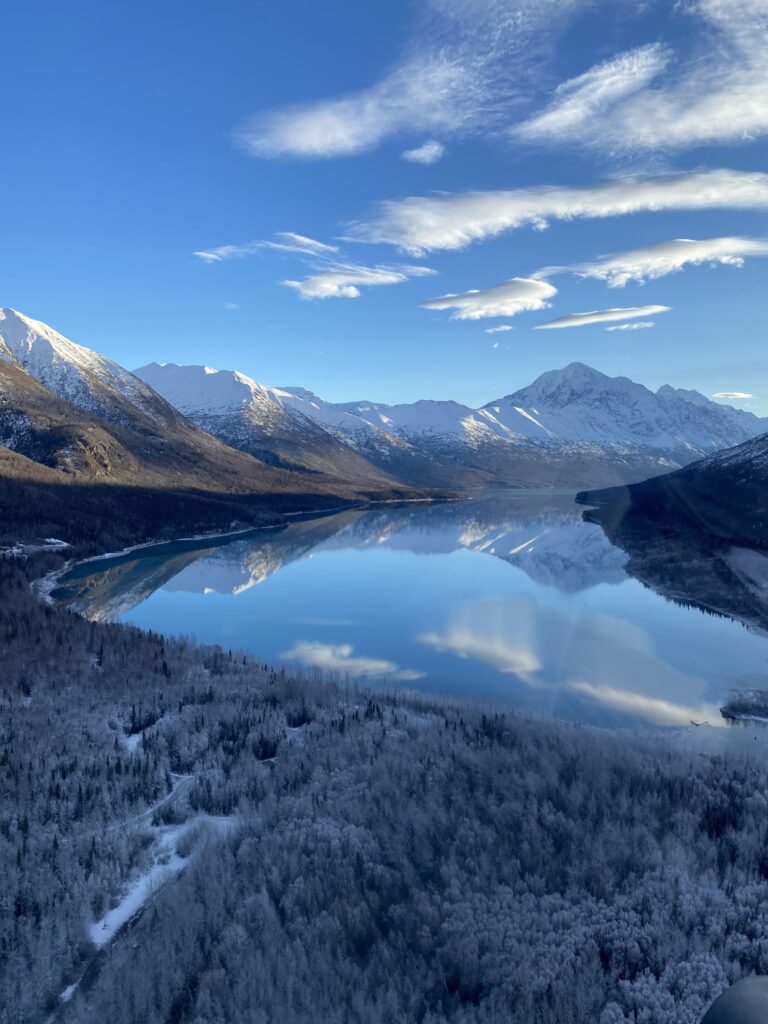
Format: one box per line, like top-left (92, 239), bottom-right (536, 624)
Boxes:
top-left (513, 0), bottom-right (768, 153)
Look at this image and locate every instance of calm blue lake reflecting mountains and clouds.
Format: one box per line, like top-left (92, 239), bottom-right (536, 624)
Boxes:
top-left (53, 492), bottom-right (768, 726)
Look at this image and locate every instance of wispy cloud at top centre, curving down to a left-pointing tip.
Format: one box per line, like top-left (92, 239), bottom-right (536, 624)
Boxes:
top-left (236, 0), bottom-right (588, 160)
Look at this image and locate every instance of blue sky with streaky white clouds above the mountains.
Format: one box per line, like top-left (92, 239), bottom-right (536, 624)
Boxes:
top-left (0, 0), bottom-right (768, 414)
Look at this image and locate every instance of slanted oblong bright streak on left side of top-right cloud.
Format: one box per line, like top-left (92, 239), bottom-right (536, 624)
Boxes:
top-left (513, 43), bottom-right (670, 141)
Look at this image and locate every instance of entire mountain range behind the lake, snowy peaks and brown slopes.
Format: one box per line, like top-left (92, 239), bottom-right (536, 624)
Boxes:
top-left (0, 309), bottom-right (768, 508)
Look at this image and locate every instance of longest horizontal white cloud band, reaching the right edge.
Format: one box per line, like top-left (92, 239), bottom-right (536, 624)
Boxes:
top-left (348, 169), bottom-right (768, 254)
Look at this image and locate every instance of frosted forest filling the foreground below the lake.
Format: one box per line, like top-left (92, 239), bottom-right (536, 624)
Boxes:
top-left (0, 554), bottom-right (768, 1024)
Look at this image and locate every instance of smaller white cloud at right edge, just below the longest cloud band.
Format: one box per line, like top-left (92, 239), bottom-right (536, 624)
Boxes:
top-left (572, 238), bottom-right (768, 288)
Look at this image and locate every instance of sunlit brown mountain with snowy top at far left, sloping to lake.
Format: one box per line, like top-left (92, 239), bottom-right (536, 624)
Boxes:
top-left (0, 309), bottom-right (428, 506)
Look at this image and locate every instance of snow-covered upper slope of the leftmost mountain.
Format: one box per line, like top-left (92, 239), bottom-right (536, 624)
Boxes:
top-left (0, 308), bottom-right (167, 425)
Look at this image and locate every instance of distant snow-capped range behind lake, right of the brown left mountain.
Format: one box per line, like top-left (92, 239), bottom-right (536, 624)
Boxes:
top-left (136, 362), bottom-right (768, 487)
